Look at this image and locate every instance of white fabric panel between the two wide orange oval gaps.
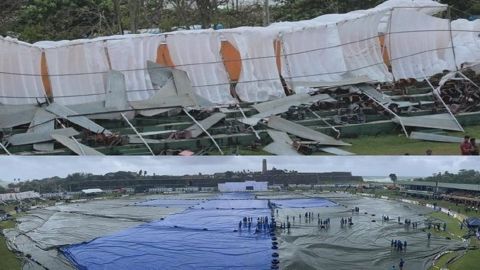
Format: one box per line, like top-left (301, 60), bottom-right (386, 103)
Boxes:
top-left (167, 30), bottom-right (235, 104)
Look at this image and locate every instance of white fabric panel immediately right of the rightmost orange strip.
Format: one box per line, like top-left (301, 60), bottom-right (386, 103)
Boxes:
top-left (386, 8), bottom-right (455, 80)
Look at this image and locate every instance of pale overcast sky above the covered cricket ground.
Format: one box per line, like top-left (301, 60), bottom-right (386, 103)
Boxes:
top-left (0, 156), bottom-right (480, 182)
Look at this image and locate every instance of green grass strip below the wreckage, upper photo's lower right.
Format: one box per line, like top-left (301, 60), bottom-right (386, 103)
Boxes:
top-left (342, 126), bottom-right (480, 155)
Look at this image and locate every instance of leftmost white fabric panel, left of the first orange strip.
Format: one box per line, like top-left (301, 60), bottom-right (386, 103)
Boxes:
top-left (0, 37), bottom-right (45, 104)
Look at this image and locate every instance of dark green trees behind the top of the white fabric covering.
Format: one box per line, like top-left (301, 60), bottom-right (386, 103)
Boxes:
top-left (0, 0), bottom-right (472, 42)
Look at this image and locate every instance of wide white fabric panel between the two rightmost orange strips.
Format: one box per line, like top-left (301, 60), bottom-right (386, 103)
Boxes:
top-left (281, 11), bottom-right (391, 93)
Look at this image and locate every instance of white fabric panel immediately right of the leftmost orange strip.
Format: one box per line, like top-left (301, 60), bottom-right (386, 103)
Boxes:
top-left (45, 41), bottom-right (108, 105)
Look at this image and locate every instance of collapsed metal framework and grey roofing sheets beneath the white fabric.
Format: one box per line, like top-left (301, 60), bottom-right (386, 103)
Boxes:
top-left (0, 59), bottom-right (480, 155)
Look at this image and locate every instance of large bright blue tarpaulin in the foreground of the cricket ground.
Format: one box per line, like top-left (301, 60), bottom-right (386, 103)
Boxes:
top-left (62, 195), bottom-right (272, 270)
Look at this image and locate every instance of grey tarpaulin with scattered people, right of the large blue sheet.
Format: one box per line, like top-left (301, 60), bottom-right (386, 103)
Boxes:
top-left (276, 193), bottom-right (468, 270)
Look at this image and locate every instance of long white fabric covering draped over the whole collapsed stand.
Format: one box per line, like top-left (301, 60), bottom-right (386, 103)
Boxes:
top-left (0, 0), bottom-right (480, 105)
